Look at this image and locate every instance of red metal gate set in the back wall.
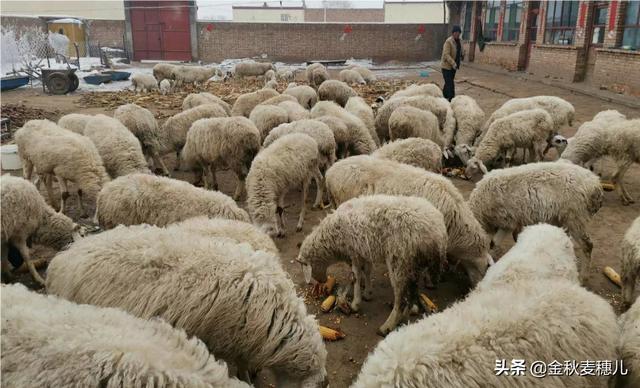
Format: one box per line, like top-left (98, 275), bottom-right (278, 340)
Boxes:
top-left (129, 1), bottom-right (192, 61)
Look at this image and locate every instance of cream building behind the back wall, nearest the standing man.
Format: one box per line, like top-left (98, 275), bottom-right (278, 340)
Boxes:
top-left (384, 0), bottom-right (449, 24)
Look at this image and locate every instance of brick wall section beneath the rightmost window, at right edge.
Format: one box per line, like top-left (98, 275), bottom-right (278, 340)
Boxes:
top-left (593, 49), bottom-right (640, 96)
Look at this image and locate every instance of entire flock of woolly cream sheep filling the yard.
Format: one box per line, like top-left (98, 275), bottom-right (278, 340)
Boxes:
top-left (1, 59), bottom-right (640, 387)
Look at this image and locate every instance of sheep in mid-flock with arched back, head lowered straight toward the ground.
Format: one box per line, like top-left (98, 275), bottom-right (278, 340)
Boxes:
top-left (247, 133), bottom-right (324, 237)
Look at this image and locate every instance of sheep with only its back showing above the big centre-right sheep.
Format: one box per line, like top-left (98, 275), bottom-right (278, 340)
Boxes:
top-left (371, 137), bottom-right (442, 173)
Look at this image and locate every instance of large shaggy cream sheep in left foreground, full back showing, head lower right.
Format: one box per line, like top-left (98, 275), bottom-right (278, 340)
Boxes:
top-left (47, 225), bottom-right (326, 387)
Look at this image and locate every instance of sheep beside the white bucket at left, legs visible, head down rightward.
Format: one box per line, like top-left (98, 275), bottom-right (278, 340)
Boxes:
top-left (14, 120), bottom-right (109, 217)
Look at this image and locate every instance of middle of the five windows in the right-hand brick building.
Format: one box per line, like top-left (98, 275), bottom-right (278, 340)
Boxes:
top-left (544, 1), bottom-right (579, 45)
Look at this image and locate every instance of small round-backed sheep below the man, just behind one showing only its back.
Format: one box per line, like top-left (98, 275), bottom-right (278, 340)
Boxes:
top-left (389, 106), bottom-right (444, 146)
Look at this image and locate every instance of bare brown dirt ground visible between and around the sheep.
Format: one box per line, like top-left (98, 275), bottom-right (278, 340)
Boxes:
top-left (2, 68), bottom-right (640, 387)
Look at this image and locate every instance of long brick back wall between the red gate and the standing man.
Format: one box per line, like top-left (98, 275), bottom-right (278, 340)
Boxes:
top-left (197, 22), bottom-right (447, 62)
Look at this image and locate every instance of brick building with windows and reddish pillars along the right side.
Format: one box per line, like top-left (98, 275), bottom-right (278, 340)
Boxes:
top-left (460, 0), bottom-right (640, 95)
